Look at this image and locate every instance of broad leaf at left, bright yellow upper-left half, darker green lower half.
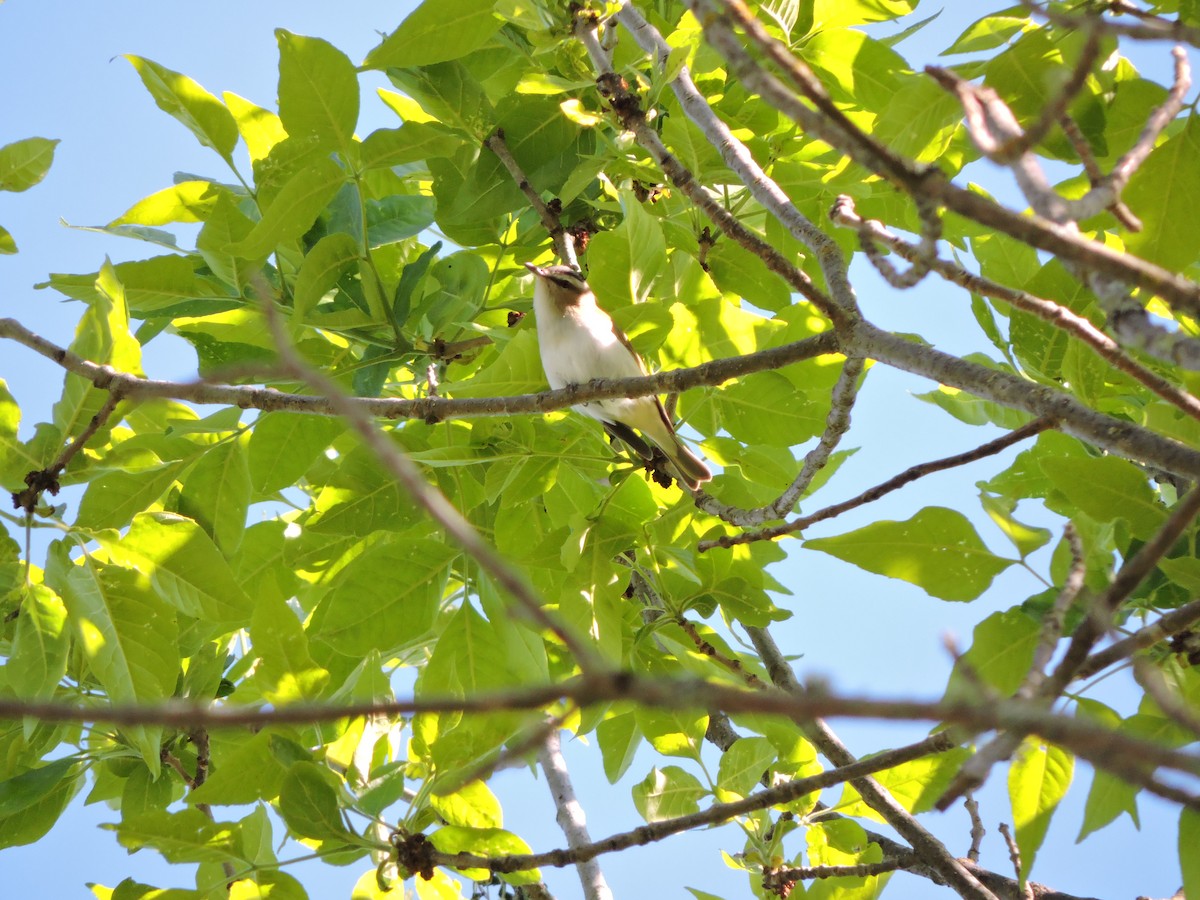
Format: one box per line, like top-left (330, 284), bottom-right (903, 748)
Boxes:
top-left (98, 512), bottom-right (253, 630)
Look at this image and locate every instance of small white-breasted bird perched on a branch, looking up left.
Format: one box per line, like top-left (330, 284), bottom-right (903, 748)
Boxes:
top-left (526, 263), bottom-right (713, 491)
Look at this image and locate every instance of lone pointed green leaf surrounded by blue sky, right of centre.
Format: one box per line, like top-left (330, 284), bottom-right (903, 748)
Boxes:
top-left (804, 506), bottom-right (1014, 600)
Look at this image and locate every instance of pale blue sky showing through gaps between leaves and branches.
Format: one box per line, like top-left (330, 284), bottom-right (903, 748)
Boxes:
top-left (0, 0), bottom-right (1178, 900)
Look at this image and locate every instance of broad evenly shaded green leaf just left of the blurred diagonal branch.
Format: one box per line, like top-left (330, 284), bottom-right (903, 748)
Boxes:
top-left (308, 540), bottom-right (458, 656)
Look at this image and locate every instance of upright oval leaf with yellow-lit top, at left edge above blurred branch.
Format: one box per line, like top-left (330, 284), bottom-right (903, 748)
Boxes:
top-left (8, 584), bottom-right (71, 700)
